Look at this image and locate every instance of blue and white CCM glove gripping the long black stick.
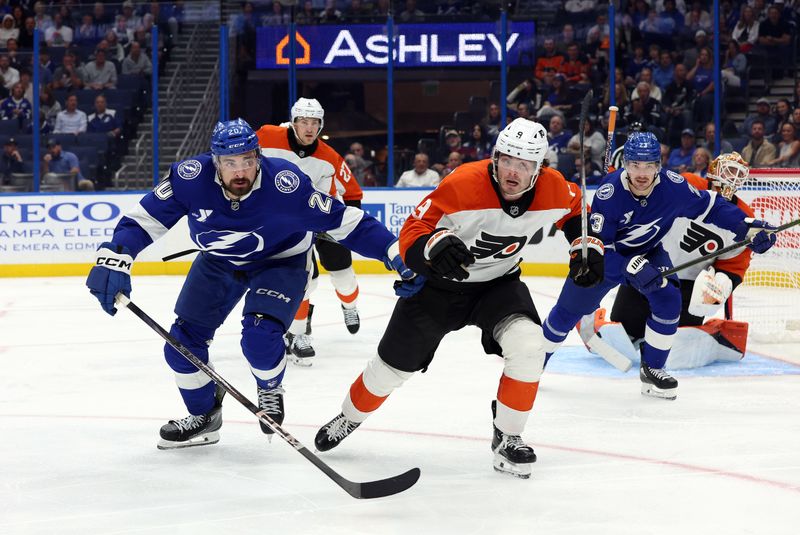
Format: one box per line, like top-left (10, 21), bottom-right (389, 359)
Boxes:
top-left (86, 242), bottom-right (133, 316)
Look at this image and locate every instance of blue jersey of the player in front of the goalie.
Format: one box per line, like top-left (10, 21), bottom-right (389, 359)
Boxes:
top-left (590, 169), bottom-right (746, 258)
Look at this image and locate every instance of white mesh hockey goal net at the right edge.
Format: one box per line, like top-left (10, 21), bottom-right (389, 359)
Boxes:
top-left (733, 169), bottom-right (800, 342)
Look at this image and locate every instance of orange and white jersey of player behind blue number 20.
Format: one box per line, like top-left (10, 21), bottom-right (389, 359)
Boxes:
top-left (256, 124), bottom-right (364, 201)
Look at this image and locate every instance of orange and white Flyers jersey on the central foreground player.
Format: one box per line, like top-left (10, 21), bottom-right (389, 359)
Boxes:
top-left (400, 160), bottom-right (581, 283)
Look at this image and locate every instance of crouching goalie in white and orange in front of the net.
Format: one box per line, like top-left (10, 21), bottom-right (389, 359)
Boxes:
top-left (579, 152), bottom-right (754, 369)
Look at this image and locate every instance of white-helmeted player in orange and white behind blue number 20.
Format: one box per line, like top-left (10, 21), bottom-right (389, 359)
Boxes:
top-left (257, 98), bottom-right (364, 366)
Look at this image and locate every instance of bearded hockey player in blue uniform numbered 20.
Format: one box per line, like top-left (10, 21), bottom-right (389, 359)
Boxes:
top-left (86, 119), bottom-right (414, 449)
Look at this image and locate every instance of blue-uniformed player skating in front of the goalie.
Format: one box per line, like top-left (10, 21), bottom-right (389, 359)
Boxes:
top-left (543, 132), bottom-right (775, 399)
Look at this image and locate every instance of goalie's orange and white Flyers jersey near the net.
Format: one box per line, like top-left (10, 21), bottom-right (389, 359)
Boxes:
top-left (661, 173), bottom-right (754, 280)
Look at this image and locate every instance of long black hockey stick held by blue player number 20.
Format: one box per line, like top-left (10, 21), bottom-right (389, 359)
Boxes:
top-left (116, 294), bottom-right (420, 499)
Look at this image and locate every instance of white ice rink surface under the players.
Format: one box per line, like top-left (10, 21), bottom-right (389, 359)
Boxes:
top-left (0, 276), bottom-right (800, 535)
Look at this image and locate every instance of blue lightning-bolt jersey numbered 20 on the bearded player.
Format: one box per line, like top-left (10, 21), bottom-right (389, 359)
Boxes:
top-left (114, 153), bottom-right (396, 270)
